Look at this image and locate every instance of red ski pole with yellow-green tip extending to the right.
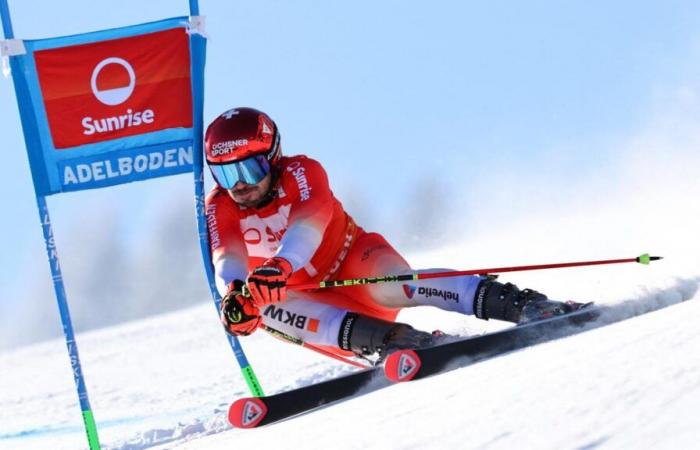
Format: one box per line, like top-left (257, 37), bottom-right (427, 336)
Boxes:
top-left (287, 253), bottom-right (663, 290)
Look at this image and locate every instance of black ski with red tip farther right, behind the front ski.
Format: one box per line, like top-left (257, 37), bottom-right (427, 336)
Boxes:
top-left (384, 305), bottom-right (610, 382)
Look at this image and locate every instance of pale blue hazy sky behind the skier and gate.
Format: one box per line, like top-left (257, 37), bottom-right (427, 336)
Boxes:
top-left (0, 0), bottom-right (700, 348)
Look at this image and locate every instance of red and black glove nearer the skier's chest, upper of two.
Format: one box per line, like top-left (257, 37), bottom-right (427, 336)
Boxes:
top-left (246, 257), bottom-right (292, 307)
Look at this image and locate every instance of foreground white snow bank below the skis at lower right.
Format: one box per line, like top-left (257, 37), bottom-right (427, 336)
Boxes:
top-left (198, 292), bottom-right (700, 449)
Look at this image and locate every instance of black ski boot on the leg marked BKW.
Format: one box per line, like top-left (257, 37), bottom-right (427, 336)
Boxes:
top-left (338, 313), bottom-right (436, 361)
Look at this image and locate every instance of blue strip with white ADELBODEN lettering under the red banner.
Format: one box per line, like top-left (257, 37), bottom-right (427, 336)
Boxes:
top-left (63, 147), bottom-right (193, 186)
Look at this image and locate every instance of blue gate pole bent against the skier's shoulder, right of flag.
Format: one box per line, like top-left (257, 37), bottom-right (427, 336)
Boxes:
top-left (189, 0), bottom-right (264, 397)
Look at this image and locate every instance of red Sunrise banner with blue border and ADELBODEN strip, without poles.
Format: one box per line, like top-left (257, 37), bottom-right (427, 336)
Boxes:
top-left (16, 17), bottom-right (194, 195)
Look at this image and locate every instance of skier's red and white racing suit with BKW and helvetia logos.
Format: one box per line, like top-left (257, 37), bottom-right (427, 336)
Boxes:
top-left (206, 156), bottom-right (479, 347)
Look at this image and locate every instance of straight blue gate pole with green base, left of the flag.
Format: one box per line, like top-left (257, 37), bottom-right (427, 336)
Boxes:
top-left (0, 0), bottom-right (100, 450)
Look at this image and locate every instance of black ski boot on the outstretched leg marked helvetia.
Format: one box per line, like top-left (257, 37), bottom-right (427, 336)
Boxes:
top-left (474, 278), bottom-right (590, 324)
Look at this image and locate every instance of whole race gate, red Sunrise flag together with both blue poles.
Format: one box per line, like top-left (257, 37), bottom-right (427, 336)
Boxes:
top-left (0, 6), bottom-right (263, 450)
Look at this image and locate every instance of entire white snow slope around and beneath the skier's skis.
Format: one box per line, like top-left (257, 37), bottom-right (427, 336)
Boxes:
top-left (0, 277), bottom-right (700, 450)
